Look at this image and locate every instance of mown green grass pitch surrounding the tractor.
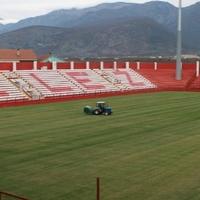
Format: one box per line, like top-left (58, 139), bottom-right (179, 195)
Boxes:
top-left (0, 93), bottom-right (200, 200)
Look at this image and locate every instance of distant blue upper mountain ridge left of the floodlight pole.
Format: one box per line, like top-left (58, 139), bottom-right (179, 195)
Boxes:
top-left (0, 1), bottom-right (176, 32)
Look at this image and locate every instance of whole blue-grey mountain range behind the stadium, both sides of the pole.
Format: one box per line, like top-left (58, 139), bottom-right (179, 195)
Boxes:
top-left (0, 1), bottom-right (200, 57)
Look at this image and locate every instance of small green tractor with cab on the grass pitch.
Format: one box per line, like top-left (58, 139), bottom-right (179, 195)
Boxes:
top-left (84, 101), bottom-right (112, 116)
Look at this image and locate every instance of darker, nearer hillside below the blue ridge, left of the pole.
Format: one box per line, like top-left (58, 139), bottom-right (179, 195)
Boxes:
top-left (0, 18), bottom-right (176, 57)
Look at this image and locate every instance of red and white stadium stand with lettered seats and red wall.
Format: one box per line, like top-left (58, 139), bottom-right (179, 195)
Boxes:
top-left (0, 62), bottom-right (200, 105)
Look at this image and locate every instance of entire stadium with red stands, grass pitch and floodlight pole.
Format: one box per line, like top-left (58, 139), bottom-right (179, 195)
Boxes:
top-left (0, 1), bottom-right (200, 200)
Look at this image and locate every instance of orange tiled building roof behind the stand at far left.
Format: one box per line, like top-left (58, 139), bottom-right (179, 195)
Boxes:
top-left (0, 49), bottom-right (37, 61)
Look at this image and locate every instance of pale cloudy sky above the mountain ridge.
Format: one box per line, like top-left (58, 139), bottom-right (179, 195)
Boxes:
top-left (0, 0), bottom-right (200, 24)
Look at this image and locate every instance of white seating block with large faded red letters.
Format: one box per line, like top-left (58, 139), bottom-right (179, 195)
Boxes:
top-left (0, 69), bottom-right (156, 99)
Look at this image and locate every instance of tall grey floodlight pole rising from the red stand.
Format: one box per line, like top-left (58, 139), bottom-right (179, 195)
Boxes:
top-left (176, 0), bottom-right (182, 80)
